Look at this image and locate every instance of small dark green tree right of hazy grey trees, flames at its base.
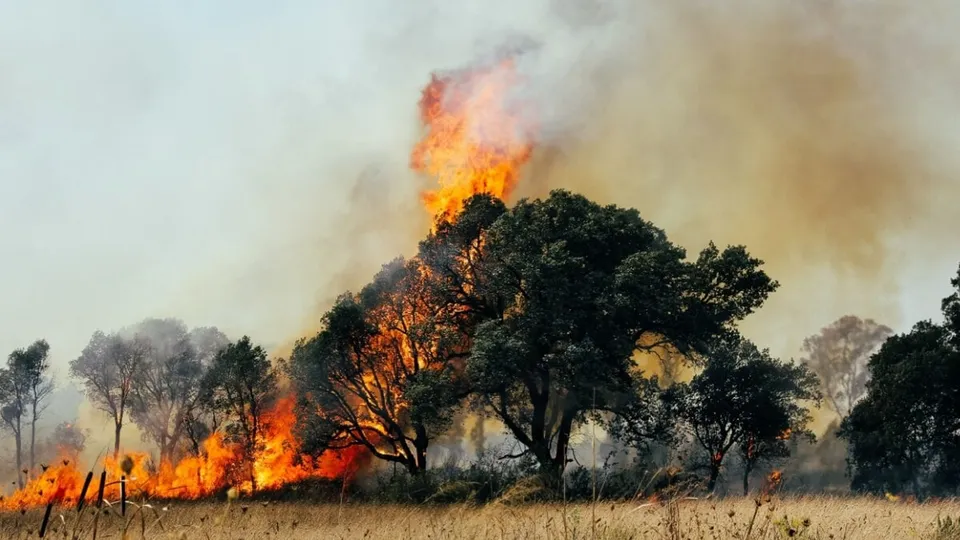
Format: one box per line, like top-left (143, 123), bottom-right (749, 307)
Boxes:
top-left (202, 336), bottom-right (277, 491)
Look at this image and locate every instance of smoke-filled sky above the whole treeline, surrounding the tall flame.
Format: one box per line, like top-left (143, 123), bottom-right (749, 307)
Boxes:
top-left (0, 0), bottom-right (960, 452)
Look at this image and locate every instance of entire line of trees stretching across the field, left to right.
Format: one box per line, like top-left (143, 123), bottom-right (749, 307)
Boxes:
top-left (7, 191), bottom-right (960, 497)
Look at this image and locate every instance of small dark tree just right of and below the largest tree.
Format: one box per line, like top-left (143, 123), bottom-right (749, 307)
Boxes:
top-left (664, 336), bottom-right (821, 494)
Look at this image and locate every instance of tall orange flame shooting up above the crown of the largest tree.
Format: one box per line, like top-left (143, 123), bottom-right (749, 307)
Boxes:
top-left (410, 58), bottom-right (535, 224)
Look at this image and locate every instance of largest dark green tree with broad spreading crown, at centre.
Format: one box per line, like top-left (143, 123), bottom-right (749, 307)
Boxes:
top-left (446, 191), bottom-right (777, 474)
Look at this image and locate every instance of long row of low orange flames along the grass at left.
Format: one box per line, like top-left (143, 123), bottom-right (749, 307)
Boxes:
top-left (0, 396), bottom-right (369, 510)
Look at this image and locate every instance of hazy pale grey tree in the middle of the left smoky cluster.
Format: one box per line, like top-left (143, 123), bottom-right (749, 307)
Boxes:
top-left (126, 319), bottom-right (204, 462)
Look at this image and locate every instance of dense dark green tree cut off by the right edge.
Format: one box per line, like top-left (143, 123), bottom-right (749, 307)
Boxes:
top-left (839, 264), bottom-right (960, 498)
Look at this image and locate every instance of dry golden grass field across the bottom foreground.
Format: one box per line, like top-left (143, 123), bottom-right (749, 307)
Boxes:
top-left (0, 497), bottom-right (960, 540)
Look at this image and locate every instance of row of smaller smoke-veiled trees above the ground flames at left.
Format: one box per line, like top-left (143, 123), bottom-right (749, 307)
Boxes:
top-left (0, 319), bottom-right (278, 487)
